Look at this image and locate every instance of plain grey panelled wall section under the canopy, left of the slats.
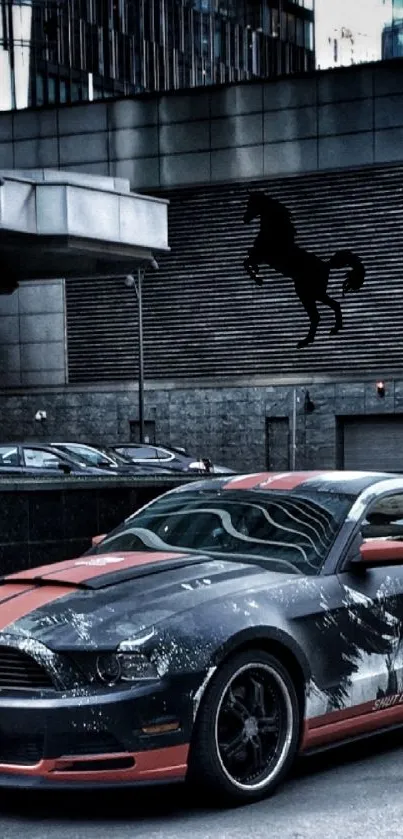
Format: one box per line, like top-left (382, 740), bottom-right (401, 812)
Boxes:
top-left (0, 280), bottom-right (67, 387)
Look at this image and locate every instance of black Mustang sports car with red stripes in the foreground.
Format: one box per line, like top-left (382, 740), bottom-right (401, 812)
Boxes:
top-left (0, 472), bottom-right (403, 802)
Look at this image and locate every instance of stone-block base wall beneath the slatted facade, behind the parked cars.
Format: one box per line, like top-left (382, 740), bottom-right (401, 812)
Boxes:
top-left (0, 379), bottom-right (403, 471)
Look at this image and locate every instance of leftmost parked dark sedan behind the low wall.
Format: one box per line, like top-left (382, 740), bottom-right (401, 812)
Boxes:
top-left (0, 443), bottom-right (115, 477)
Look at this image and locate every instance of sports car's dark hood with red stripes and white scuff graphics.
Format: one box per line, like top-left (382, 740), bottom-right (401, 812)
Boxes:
top-left (0, 551), bottom-right (301, 650)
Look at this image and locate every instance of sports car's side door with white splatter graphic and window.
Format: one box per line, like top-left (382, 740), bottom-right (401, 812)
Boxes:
top-left (338, 492), bottom-right (403, 720)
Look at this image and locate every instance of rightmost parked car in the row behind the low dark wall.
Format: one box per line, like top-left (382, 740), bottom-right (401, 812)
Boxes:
top-left (112, 443), bottom-right (235, 475)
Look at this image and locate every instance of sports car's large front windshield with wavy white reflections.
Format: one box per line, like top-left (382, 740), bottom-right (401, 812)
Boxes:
top-left (89, 490), bottom-right (354, 574)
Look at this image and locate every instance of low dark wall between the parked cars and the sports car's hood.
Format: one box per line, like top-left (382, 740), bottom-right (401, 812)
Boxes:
top-left (0, 475), bottom-right (193, 574)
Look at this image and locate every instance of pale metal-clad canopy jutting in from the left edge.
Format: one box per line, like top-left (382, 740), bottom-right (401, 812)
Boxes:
top-left (0, 169), bottom-right (169, 292)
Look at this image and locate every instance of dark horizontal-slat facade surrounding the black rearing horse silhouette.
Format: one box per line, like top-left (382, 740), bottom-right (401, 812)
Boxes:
top-left (66, 164), bottom-right (403, 382)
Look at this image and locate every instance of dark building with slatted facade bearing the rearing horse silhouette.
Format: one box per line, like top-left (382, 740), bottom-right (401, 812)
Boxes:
top-left (0, 60), bottom-right (403, 472)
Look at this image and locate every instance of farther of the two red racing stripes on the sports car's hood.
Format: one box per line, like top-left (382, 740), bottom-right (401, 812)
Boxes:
top-left (8, 551), bottom-right (187, 586)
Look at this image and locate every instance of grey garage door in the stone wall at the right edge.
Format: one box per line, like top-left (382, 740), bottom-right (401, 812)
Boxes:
top-left (341, 416), bottom-right (403, 472)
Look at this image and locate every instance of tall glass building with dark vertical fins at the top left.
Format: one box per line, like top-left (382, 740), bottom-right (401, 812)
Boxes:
top-left (0, 0), bottom-right (315, 110)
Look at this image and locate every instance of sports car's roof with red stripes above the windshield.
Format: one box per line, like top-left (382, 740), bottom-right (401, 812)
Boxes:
top-left (173, 470), bottom-right (403, 495)
